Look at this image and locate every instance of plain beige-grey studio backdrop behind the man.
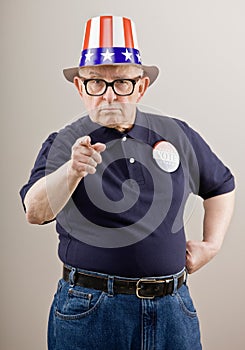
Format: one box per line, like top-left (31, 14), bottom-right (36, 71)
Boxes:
top-left (0, 0), bottom-right (245, 350)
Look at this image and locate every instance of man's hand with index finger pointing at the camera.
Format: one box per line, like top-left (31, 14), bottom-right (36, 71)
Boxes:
top-left (70, 136), bottom-right (106, 178)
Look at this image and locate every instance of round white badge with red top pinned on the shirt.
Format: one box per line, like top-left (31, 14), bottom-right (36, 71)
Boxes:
top-left (153, 141), bottom-right (180, 173)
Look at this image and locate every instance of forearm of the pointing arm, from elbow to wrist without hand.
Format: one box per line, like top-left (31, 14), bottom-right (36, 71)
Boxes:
top-left (24, 161), bottom-right (81, 224)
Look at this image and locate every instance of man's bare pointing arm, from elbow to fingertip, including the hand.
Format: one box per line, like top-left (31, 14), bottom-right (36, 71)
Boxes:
top-left (24, 136), bottom-right (106, 225)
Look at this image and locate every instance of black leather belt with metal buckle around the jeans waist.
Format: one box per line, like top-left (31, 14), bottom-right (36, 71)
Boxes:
top-left (63, 266), bottom-right (185, 299)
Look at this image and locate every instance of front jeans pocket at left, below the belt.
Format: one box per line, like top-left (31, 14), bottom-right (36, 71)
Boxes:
top-left (55, 281), bottom-right (106, 320)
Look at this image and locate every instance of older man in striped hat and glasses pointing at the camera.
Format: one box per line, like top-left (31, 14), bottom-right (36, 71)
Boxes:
top-left (21, 16), bottom-right (234, 350)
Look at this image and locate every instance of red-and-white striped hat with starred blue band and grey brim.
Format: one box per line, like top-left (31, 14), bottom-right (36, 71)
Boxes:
top-left (63, 16), bottom-right (159, 85)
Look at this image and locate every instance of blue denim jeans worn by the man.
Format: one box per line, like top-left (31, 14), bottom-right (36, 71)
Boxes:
top-left (48, 270), bottom-right (202, 350)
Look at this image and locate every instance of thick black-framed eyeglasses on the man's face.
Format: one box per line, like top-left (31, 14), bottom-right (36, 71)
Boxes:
top-left (81, 77), bottom-right (141, 96)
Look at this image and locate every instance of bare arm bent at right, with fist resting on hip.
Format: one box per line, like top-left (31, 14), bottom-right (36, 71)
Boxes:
top-left (186, 191), bottom-right (234, 273)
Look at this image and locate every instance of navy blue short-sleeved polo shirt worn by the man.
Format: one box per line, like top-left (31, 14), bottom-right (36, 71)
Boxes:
top-left (20, 110), bottom-right (234, 277)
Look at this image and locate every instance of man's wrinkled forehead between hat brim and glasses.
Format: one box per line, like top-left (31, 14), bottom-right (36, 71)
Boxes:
top-left (79, 65), bottom-right (143, 78)
